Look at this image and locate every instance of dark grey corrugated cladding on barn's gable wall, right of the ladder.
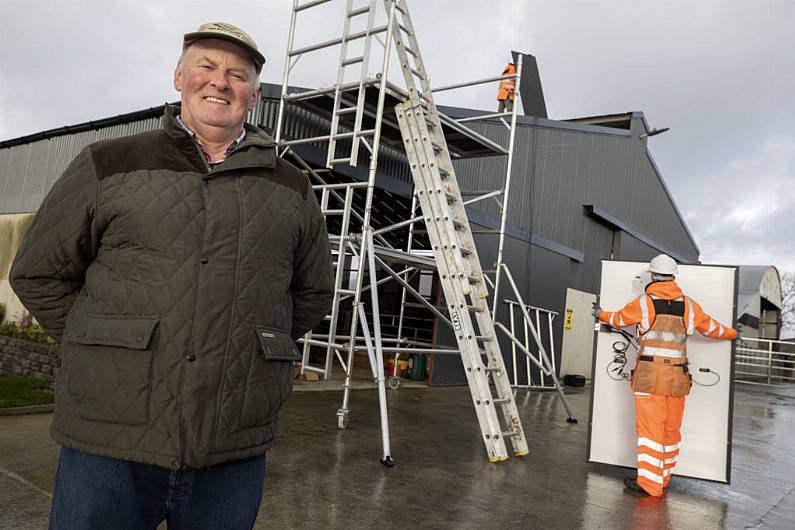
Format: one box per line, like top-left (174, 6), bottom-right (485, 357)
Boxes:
top-left (456, 115), bottom-right (698, 261)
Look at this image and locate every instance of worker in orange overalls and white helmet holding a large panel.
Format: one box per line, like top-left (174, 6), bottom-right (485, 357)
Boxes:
top-left (594, 254), bottom-right (737, 497)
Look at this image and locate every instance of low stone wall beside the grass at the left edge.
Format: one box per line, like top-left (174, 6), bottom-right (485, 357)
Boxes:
top-left (0, 336), bottom-right (61, 387)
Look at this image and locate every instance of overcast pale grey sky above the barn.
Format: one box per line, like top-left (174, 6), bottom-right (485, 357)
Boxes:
top-left (0, 0), bottom-right (795, 271)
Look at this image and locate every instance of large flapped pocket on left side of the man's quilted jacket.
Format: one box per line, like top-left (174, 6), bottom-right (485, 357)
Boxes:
top-left (62, 315), bottom-right (159, 425)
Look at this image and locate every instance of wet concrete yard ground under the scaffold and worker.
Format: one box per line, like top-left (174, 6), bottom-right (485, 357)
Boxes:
top-left (0, 378), bottom-right (795, 530)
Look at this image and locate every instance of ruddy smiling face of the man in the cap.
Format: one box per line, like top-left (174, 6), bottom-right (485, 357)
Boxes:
top-left (174, 39), bottom-right (259, 134)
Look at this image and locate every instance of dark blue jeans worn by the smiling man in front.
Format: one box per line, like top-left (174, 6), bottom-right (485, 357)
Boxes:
top-left (50, 447), bottom-right (265, 530)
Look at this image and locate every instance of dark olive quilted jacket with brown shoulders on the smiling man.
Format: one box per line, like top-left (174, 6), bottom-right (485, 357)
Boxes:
top-left (11, 107), bottom-right (332, 468)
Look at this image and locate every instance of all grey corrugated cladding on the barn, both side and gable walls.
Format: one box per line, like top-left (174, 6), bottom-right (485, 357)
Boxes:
top-left (0, 85), bottom-right (698, 261)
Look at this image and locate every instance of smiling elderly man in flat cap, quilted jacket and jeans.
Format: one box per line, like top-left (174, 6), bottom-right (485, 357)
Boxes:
top-left (11, 23), bottom-right (332, 530)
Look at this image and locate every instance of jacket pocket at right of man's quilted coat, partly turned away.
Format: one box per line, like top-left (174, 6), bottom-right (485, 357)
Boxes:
top-left (240, 326), bottom-right (301, 427)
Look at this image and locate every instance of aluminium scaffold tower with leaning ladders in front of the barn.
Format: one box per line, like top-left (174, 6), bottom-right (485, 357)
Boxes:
top-left (275, 0), bottom-right (576, 466)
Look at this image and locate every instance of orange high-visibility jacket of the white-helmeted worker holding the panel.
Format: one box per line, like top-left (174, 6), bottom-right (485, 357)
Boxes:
top-left (599, 281), bottom-right (737, 340)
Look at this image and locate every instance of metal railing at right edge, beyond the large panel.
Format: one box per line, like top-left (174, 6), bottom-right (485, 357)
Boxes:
top-left (734, 337), bottom-right (795, 386)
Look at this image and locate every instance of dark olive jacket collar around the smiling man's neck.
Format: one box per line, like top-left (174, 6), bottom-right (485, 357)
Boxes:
top-left (163, 104), bottom-right (276, 171)
